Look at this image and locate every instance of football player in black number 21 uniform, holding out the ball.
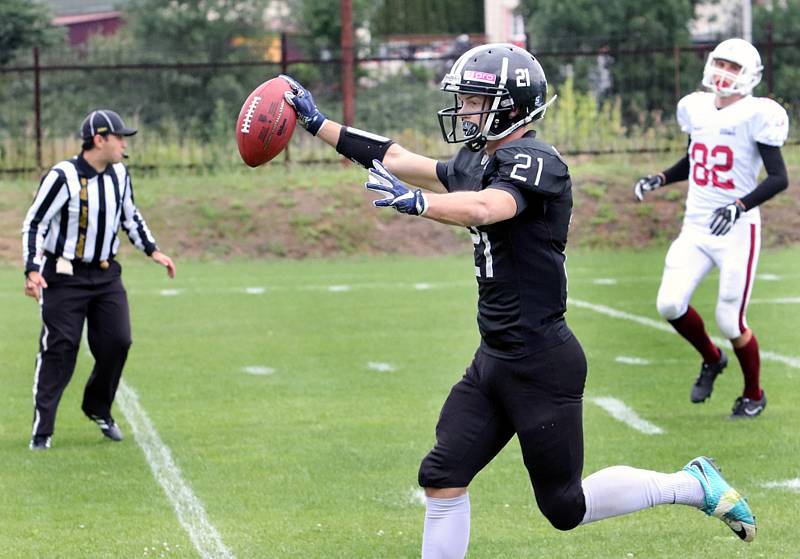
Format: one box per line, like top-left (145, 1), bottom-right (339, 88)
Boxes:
top-left (285, 44), bottom-right (756, 559)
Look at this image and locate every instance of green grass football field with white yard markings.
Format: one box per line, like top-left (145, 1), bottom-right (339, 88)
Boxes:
top-left (0, 248), bottom-right (800, 559)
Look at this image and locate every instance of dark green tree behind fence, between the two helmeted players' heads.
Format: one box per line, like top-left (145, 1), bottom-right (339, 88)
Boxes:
top-left (520, 0), bottom-right (702, 120)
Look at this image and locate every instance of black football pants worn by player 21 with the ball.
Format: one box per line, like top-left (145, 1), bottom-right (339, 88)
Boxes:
top-left (419, 336), bottom-right (586, 530)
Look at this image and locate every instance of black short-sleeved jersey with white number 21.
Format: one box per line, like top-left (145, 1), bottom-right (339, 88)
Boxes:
top-left (437, 132), bottom-right (572, 357)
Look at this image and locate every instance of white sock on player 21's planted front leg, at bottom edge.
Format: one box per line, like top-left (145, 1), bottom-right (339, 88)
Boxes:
top-left (422, 493), bottom-right (469, 559)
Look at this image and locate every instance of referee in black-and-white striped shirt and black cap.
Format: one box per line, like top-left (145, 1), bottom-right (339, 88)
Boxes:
top-left (22, 110), bottom-right (175, 450)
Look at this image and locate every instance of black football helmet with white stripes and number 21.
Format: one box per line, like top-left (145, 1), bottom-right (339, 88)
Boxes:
top-left (437, 43), bottom-right (555, 151)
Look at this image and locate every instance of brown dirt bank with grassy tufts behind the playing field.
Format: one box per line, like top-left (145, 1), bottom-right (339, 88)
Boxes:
top-left (0, 166), bottom-right (800, 263)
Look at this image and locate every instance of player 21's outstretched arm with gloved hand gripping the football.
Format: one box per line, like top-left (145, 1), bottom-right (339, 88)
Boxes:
top-left (281, 74), bottom-right (445, 192)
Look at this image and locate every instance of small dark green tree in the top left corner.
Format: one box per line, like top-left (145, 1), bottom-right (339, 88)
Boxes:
top-left (0, 0), bottom-right (62, 65)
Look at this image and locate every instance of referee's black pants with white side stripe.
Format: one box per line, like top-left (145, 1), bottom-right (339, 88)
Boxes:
top-left (33, 258), bottom-right (131, 442)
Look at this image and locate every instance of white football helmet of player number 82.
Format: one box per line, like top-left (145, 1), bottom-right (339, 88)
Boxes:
top-left (703, 39), bottom-right (764, 97)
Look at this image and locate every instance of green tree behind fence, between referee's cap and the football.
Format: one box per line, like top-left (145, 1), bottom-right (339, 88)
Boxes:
top-left (101, 0), bottom-right (271, 138)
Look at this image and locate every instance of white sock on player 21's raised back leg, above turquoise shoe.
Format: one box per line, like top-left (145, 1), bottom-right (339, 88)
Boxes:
top-left (581, 466), bottom-right (705, 524)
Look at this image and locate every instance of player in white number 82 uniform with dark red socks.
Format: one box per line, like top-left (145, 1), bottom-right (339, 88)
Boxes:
top-left (634, 39), bottom-right (789, 418)
